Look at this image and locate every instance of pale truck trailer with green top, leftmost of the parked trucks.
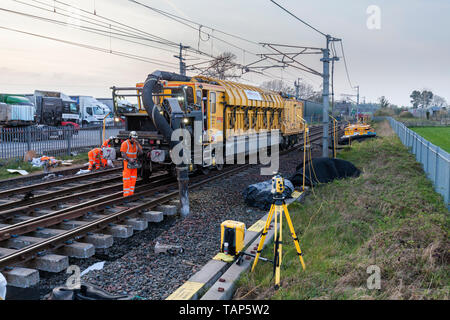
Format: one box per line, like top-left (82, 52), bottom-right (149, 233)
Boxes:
top-left (0, 94), bottom-right (35, 127)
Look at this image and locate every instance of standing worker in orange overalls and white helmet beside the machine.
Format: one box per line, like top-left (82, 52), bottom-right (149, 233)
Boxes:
top-left (120, 131), bottom-right (142, 197)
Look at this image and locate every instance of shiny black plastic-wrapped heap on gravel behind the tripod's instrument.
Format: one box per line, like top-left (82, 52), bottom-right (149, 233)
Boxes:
top-left (242, 179), bottom-right (294, 210)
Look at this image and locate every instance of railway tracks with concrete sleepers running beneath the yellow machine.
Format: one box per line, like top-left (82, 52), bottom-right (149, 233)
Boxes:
top-left (0, 127), bottom-right (342, 294)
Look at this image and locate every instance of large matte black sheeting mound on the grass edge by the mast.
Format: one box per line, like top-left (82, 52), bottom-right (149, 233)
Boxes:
top-left (289, 158), bottom-right (361, 187)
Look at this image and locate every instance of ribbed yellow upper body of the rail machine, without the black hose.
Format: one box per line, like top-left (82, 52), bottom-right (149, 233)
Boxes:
top-left (136, 76), bottom-right (304, 144)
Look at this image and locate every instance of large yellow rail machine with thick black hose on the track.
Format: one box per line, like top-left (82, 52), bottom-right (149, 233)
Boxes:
top-left (111, 71), bottom-right (304, 180)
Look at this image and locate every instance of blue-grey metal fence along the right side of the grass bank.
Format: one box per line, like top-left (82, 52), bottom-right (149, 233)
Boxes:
top-left (388, 117), bottom-right (450, 210)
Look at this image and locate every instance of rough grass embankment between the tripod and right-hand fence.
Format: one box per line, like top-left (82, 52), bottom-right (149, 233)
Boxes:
top-left (234, 121), bottom-right (450, 299)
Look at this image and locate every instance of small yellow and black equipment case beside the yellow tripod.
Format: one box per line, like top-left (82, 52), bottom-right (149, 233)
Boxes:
top-left (220, 220), bottom-right (245, 256)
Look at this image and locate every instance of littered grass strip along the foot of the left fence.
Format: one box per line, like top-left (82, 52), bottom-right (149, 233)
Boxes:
top-left (0, 152), bottom-right (88, 180)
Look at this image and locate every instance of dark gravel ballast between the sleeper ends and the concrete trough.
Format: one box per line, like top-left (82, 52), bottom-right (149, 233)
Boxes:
top-left (40, 151), bottom-right (320, 300)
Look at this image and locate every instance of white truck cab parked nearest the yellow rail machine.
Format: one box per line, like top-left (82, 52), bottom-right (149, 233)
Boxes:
top-left (70, 96), bottom-right (114, 126)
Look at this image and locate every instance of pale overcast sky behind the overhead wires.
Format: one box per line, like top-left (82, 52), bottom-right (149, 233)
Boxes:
top-left (0, 0), bottom-right (450, 105)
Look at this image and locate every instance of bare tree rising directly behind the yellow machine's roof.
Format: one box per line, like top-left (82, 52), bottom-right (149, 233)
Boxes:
top-left (202, 51), bottom-right (241, 80)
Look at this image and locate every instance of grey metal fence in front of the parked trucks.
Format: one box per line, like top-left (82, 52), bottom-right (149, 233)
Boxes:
top-left (0, 126), bottom-right (123, 160)
